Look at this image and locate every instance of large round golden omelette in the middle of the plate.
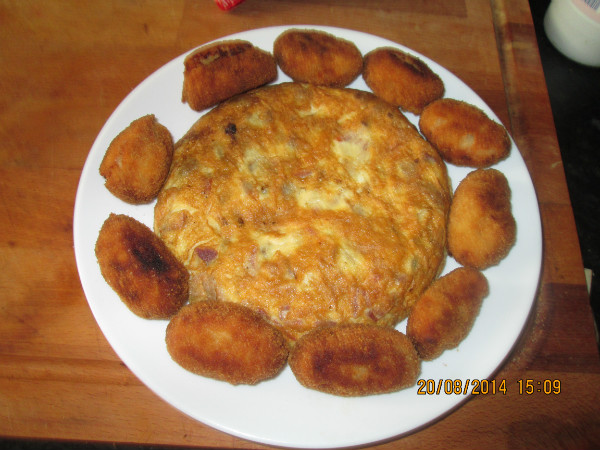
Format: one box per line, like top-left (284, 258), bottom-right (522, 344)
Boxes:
top-left (154, 83), bottom-right (451, 341)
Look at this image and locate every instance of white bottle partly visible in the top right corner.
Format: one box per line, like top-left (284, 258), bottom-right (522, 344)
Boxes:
top-left (544, 0), bottom-right (600, 67)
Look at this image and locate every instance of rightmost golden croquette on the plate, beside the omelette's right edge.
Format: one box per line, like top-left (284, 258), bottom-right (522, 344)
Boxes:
top-left (448, 169), bottom-right (517, 270)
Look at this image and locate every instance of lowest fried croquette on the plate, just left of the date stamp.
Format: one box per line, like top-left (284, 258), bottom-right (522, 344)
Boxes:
top-left (289, 324), bottom-right (421, 396)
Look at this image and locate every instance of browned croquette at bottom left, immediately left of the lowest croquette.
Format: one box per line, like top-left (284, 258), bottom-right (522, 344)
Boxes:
top-left (166, 300), bottom-right (288, 384)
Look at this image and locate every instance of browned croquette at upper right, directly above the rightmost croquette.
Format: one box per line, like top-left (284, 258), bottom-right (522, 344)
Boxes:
top-left (419, 98), bottom-right (511, 168)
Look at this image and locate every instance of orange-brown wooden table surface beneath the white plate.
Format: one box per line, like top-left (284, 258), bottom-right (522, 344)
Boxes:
top-left (0, 0), bottom-right (600, 448)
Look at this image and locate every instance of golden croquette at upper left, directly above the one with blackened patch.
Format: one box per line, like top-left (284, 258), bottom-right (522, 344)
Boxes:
top-left (100, 114), bottom-right (173, 204)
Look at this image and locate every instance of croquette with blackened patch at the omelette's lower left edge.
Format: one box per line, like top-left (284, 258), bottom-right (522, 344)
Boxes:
top-left (96, 214), bottom-right (189, 319)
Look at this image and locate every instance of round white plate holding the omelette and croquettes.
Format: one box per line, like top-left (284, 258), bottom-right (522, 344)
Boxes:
top-left (73, 26), bottom-right (542, 448)
